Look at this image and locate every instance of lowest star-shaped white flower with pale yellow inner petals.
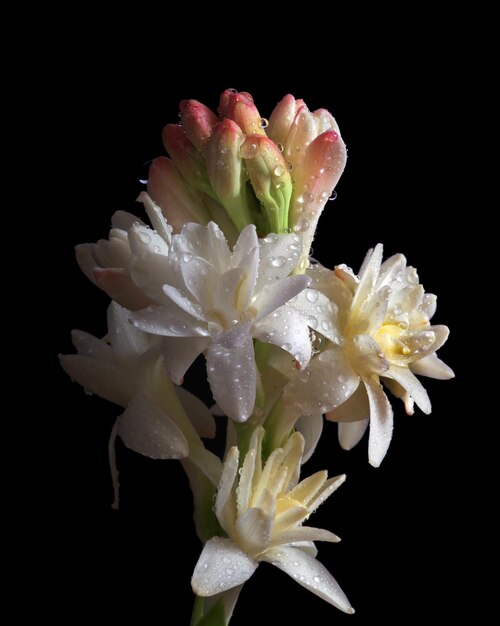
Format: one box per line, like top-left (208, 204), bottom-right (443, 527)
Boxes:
top-left (191, 427), bottom-right (354, 613)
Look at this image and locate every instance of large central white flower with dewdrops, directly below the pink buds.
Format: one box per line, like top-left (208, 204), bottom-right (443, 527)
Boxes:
top-left (128, 217), bottom-right (311, 422)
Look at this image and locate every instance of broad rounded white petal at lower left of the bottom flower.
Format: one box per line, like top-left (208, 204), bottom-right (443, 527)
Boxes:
top-left (191, 537), bottom-right (258, 598)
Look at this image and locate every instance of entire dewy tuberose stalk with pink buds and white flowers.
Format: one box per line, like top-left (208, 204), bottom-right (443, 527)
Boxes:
top-left (60, 89), bottom-right (453, 626)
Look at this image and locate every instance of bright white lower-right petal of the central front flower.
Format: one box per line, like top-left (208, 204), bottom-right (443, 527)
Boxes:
top-left (254, 304), bottom-right (312, 368)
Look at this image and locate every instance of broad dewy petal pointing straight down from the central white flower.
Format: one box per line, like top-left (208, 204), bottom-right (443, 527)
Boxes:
top-left (207, 336), bottom-right (257, 422)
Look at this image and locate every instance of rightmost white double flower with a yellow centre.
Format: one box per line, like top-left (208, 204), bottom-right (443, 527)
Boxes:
top-left (286, 244), bottom-right (453, 467)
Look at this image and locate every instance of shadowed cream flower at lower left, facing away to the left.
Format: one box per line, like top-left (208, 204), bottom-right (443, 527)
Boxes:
top-left (59, 302), bottom-right (220, 484)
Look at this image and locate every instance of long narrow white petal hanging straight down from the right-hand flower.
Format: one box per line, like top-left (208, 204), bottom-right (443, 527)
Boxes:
top-left (363, 378), bottom-right (393, 467)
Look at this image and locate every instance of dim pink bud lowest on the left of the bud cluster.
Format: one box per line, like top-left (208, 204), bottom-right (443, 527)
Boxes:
top-left (148, 157), bottom-right (209, 233)
